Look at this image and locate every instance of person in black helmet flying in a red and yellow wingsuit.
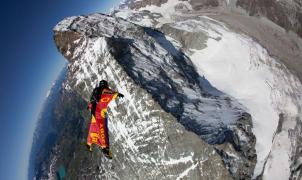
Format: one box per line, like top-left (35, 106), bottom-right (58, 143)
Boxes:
top-left (87, 80), bottom-right (124, 159)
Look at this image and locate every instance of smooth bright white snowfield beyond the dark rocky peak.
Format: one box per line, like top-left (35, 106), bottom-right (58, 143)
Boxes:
top-left (184, 18), bottom-right (302, 179)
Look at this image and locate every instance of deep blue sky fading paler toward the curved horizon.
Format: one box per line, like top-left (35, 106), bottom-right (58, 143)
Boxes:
top-left (0, 0), bottom-right (120, 180)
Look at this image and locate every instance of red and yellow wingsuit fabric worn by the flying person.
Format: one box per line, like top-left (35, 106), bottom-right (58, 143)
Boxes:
top-left (87, 88), bottom-right (119, 151)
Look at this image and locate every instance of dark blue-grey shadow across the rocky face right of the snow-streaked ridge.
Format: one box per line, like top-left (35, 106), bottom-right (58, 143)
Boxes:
top-left (107, 27), bottom-right (241, 144)
